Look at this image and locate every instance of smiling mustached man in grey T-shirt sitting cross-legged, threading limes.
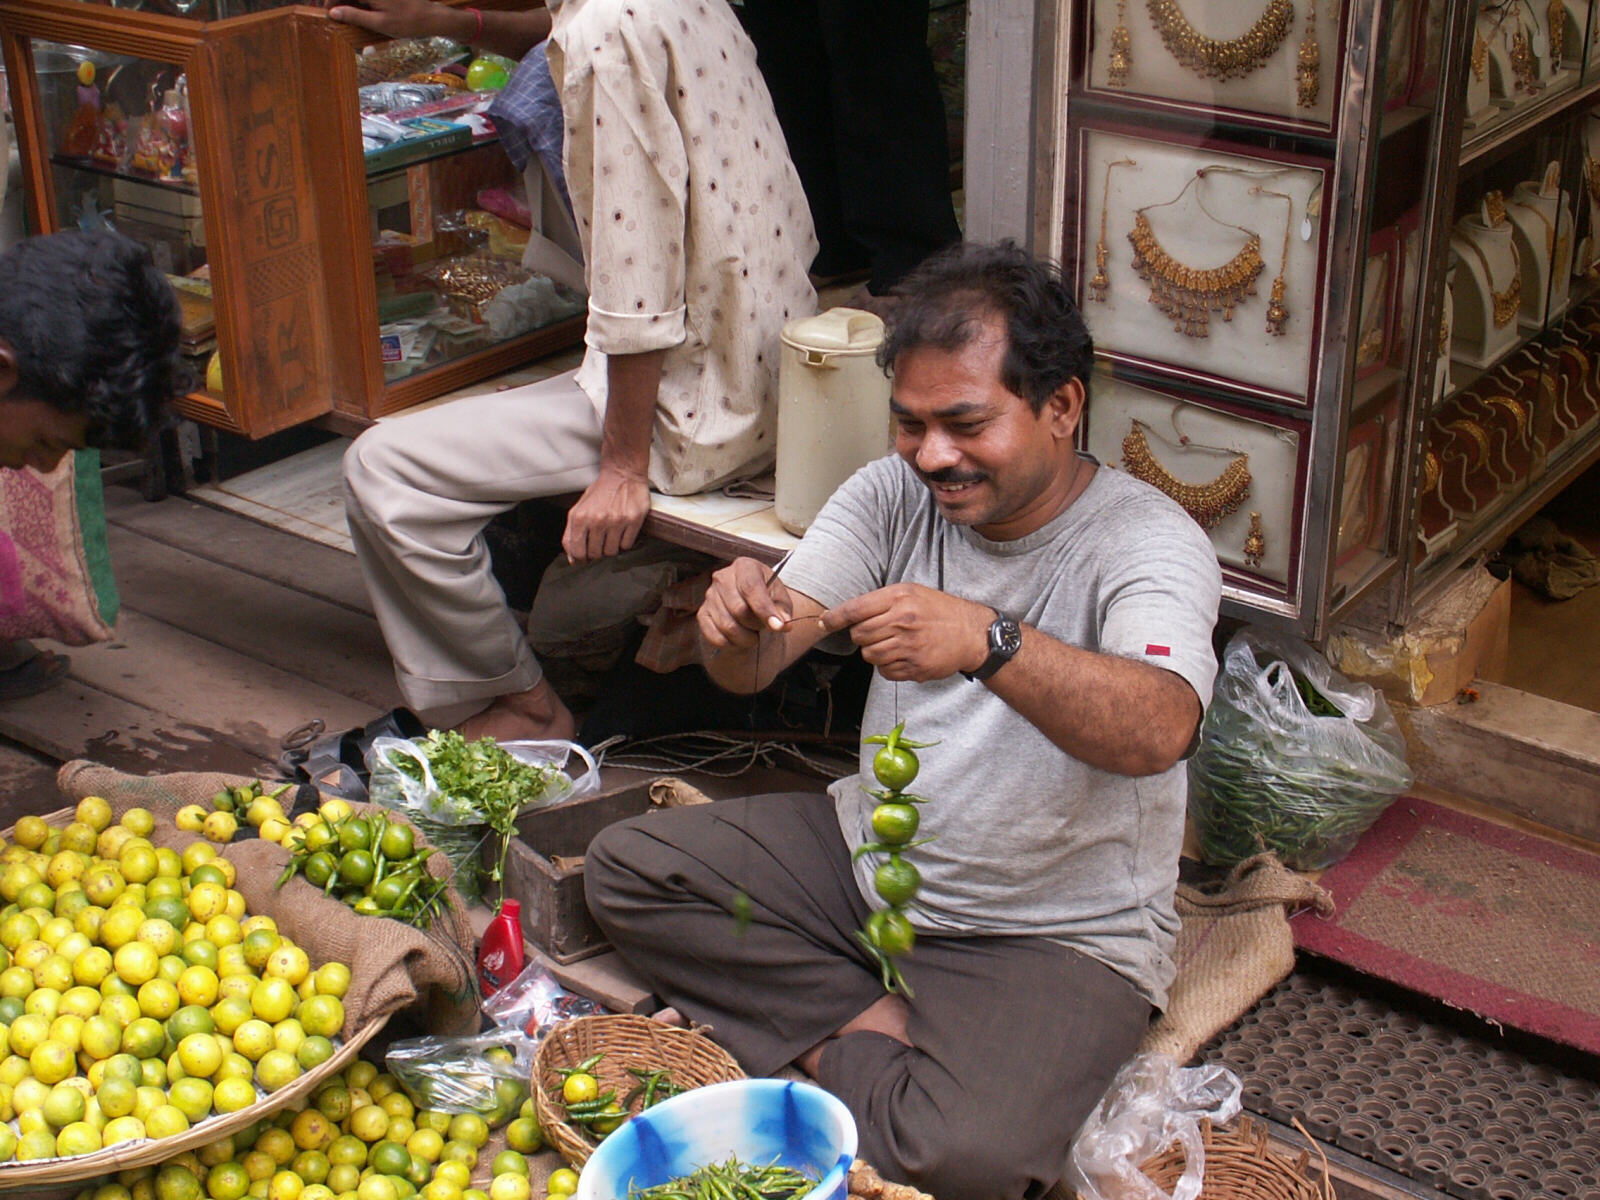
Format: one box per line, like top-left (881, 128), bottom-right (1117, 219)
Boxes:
top-left (586, 245), bottom-right (1221, 1200)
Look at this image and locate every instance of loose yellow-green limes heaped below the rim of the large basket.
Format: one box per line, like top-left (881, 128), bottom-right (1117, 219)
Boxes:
top-left (77, 1061), bottom-right (550, 1200)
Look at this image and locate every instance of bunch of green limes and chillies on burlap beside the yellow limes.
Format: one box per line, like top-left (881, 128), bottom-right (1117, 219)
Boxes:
top-left (278, 813), bottom-right (450, 930)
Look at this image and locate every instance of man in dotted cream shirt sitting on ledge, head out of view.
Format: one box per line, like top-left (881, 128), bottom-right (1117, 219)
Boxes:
top-left (344, 0), bottom-right (816, 739)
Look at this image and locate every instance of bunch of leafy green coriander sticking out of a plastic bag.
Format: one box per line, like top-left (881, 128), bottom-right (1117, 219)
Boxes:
top-left (394, 730), bottom-right (566, 899)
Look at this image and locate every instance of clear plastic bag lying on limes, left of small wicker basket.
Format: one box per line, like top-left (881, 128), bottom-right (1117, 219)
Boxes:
top-left (384, 1029), bottom-right (538, 1128)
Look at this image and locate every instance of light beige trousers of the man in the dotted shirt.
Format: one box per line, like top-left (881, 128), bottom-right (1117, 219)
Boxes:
top-left (344, 373), bottom-right (600, 710)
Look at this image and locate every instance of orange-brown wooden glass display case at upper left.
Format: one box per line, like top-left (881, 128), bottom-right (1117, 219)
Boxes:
top-left (0, 0), bottom-right (584, 437)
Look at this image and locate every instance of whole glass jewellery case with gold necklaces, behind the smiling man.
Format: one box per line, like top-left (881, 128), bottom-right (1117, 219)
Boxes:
top-left (1040, 0), bottom-right (1600, 640)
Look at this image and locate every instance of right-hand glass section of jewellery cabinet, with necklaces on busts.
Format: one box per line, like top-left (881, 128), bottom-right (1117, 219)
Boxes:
top-left (1394, 0), bottom-right (1600, 621)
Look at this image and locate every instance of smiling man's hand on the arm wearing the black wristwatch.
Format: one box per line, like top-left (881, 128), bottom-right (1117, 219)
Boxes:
top-left (822, 584), bottom-right (994, 683)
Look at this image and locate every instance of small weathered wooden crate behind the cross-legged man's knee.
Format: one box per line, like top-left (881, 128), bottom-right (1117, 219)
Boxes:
top-left (506, 784), bottom-right (651, 963)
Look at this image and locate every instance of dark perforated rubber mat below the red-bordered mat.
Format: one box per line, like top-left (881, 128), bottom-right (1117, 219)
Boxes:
top-left (1200, 970), bottom-right (1600, 1200)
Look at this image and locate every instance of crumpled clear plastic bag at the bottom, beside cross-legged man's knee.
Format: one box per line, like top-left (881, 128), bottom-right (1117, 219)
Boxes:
top-left (1072, 1054), bottom-right (1240, 1200)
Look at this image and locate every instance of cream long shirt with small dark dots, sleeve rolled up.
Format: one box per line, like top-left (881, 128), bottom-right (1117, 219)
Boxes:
top-left (549, 0), bottom-right (816, 494)
